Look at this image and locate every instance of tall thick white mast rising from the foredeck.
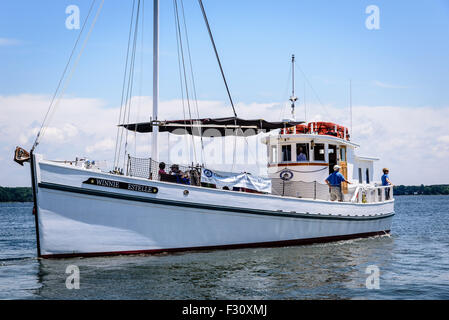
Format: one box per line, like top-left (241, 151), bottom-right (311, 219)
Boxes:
top-left (151, 0), bottom-right (159, 161)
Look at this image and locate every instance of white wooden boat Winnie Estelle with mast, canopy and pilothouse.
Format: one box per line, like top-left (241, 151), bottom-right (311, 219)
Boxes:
top-left (16, 0), bottom-right (394, 258)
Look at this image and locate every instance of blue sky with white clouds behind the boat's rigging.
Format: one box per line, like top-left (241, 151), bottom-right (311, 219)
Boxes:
top-left (0, 0), bottom-right (449, 186)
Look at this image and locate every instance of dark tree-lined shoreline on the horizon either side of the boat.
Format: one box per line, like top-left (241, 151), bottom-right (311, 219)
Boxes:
top-left (0, 184), bottom-right (449, 202)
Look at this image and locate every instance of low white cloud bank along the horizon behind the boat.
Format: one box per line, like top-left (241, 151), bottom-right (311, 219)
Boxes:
top-left (0, 95), bottom-right (449, 186)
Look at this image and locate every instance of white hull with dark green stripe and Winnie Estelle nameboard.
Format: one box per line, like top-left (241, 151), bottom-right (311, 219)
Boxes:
top-left (35, 155), bottom-right (394, 257)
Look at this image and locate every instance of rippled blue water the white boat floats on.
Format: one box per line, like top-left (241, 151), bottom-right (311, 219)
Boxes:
top-left (0, 196), bottom-right (449, 299)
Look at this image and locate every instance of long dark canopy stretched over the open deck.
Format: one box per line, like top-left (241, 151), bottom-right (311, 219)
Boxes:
top-left (120, 117), bottom-right (304, 136)
